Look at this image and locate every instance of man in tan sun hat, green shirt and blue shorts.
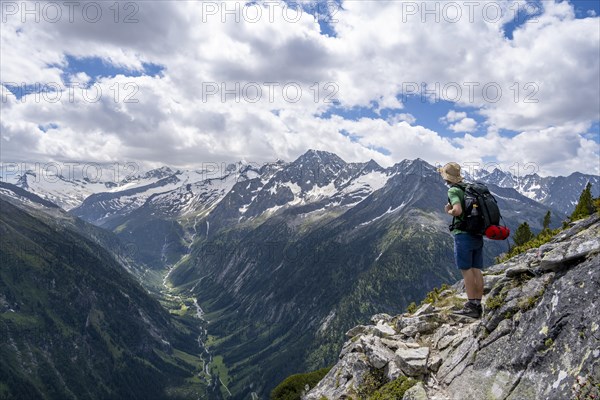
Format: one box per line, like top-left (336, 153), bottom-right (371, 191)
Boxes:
top-left (438, 162), bottom-right (483, 318)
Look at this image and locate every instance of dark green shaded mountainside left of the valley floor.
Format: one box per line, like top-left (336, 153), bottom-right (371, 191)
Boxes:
top-left (0, 189), bottom-right (214, 400)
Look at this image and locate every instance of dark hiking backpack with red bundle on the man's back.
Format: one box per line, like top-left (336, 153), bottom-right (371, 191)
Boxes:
top-left (450, 182), bottom-right (510, 240)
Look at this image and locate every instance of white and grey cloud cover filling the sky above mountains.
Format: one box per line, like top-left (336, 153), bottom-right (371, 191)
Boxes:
top-left (0, 1), bottom-right (600, 174)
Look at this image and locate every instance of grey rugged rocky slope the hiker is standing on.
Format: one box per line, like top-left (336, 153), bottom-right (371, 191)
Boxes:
top-left (304, 216), bottom-right (600, 400)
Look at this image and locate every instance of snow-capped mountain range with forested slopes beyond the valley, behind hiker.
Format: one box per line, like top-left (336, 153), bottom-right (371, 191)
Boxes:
top-left (0, 150), bottom-right (599, 398)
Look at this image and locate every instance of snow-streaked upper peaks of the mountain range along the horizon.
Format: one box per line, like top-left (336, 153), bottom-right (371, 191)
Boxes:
top-left (5, 153), bottom-right (600, 223)
